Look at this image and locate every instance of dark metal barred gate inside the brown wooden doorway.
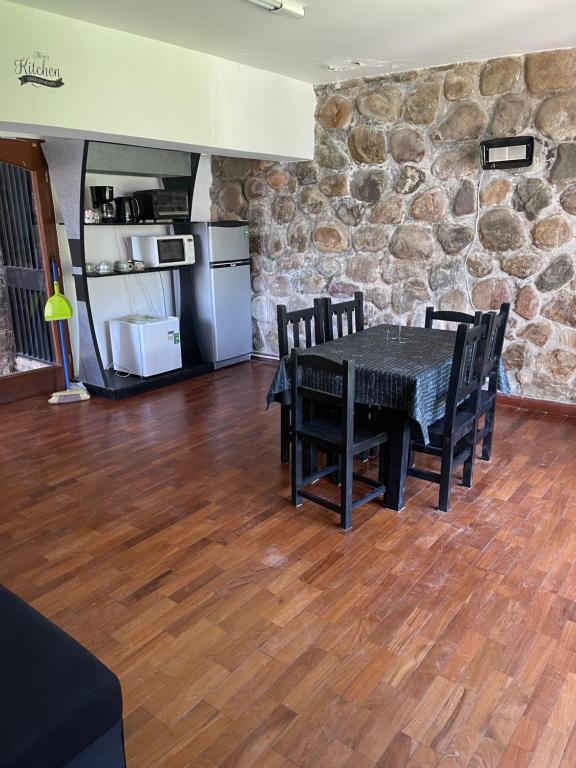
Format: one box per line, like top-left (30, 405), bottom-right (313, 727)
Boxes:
top-left (0, 162), bottom-right (55, 363)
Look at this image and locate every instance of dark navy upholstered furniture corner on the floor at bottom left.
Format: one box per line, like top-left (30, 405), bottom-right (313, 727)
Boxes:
top-left (0, 586), bottom-right (126, 768)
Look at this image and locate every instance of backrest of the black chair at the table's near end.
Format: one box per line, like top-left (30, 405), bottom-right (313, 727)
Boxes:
top-left (291, 349), bottom-right (356, 448)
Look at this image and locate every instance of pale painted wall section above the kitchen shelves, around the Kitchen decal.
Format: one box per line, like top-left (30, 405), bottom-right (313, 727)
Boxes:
top-left (0, 0), bottom-right (315, 159)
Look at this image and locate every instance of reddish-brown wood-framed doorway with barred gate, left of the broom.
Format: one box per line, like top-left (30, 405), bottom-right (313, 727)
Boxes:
top-left (0, 139), bottom-right (71, 404)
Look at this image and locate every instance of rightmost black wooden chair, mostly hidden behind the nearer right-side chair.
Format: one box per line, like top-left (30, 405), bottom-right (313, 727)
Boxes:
top-left (476, 303), bottom-right (510, 461)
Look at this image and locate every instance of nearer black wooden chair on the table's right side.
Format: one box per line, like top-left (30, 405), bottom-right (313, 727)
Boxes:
top-left (408, 314), bottom-right (494, 512)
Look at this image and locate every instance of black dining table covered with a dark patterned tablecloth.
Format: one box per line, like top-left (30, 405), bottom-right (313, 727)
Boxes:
top-left (267, 325), bottom-right (510, 511)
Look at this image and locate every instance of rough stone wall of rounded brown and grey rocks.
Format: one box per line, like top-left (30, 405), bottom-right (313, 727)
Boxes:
top-left (211, 50), bottom-right (576, 400)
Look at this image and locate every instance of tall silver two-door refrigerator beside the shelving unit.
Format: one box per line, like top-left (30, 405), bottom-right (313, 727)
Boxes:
top-left (191, 221), bottom-right (252, 368)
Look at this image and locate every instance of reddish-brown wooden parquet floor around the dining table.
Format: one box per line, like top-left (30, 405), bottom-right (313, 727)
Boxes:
top-left (0, 363), bottom-right (576, 768)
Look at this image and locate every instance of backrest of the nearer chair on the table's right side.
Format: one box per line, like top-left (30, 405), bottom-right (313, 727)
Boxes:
top-left (444, 314), bottom-right (493, 435)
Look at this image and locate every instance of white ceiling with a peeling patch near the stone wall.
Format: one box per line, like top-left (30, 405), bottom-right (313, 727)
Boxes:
top-left (12, 0), bottom-right (576, 83)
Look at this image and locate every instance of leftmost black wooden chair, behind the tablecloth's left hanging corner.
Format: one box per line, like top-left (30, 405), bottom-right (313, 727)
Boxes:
top-left (276, 299), bottom-right (326, 464)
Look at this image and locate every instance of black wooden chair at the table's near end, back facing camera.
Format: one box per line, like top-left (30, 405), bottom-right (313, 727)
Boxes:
top-left (292, 350), bottom-right (388, 530)
